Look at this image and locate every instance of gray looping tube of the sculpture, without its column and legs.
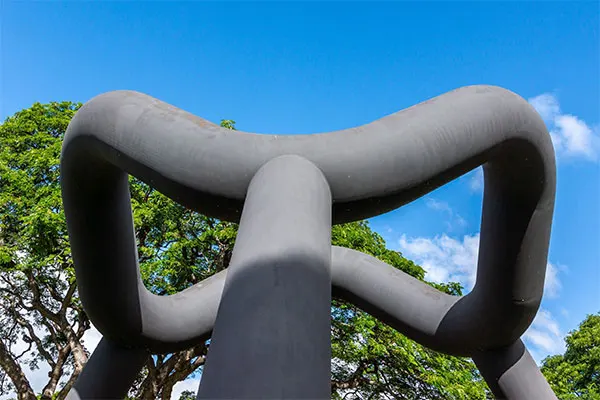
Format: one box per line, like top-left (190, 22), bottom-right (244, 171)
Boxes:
top-left (61, 86), bottom-right (555, 396)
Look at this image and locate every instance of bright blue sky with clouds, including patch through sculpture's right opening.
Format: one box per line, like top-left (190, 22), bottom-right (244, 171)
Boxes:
top-left (0, 0), bottom-right (600, 396)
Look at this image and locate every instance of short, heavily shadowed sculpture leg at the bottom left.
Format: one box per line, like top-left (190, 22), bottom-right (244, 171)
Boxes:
top-left (66, 338), bottom-right (149, 400)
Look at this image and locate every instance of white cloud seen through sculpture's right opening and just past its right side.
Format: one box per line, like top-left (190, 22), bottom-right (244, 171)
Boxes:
top-left (399, 233), bottom-right (565, 298)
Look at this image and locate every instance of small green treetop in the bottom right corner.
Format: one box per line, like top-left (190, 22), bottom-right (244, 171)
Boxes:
top-left (541, 313), bottom-right (600, 400)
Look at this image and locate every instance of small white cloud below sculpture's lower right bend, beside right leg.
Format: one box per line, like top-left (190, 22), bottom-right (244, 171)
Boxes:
top-left (523, 308), bottom-right (565, 365)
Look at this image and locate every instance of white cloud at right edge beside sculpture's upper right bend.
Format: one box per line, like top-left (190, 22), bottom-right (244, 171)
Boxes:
top-left (529, 93), bottom-right (600, 161)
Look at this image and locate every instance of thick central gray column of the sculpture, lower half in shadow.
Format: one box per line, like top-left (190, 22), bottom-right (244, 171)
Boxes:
top-left (198, 156), bottom-right (332, 399)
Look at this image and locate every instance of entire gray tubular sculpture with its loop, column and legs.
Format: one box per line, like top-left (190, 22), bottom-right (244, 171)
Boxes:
top-left (61, 86), bottom-right (555, 399)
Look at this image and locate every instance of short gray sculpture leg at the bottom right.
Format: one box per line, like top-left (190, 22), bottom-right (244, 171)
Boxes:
top-left (473, 340), bottom-right (557, 400)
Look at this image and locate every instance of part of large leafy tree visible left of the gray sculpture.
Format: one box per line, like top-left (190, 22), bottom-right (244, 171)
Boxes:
top-left (0, 102), bottom-right (89, 399)
